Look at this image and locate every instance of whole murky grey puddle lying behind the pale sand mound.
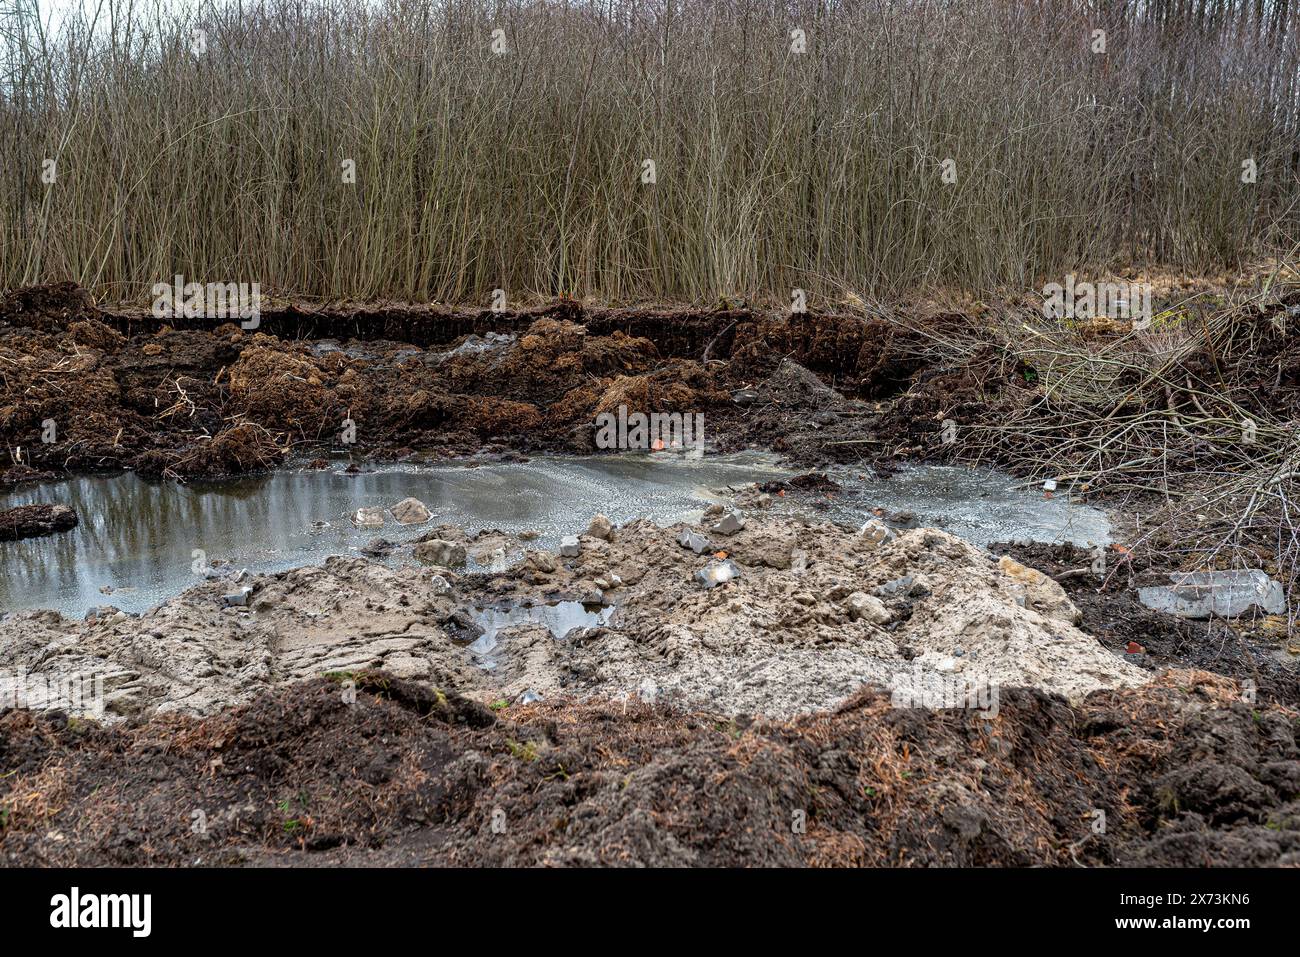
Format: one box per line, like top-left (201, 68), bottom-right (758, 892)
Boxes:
top-left (0, 452), bottom-right (1109, 618)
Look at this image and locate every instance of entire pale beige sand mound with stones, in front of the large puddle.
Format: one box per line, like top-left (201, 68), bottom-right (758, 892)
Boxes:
top-left (0, 520), bottom-right (1147, 716)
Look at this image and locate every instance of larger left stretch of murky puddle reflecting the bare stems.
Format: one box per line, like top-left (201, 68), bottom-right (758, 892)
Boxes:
top-left (0, 454), bottom-right (785, 618)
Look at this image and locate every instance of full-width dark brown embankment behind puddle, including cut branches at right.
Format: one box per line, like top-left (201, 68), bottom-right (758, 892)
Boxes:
top-left (0, 281), bottom-right (1300, 494)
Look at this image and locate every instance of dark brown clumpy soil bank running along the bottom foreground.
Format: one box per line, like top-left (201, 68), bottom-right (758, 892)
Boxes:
top-left (0, 671), bottom-right (1300, 867)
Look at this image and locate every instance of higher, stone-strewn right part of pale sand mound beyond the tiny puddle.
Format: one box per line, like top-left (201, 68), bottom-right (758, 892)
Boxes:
top-left (488, 521), bottom-right (1145, 715)
